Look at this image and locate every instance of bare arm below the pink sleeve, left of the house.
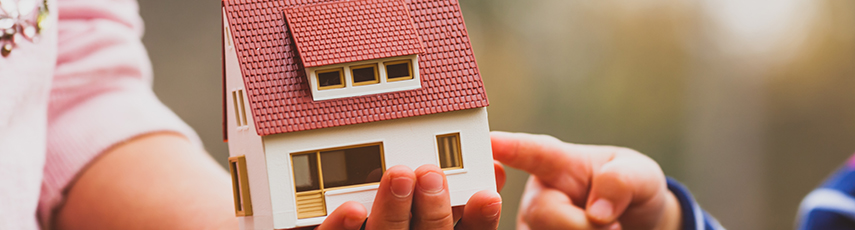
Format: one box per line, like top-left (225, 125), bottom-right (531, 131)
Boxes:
top-left (53, 133), bottom-right (238, 229)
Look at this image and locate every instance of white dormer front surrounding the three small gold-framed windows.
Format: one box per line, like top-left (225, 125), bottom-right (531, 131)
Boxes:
top-left (306, 55), bottom-right (422, 101)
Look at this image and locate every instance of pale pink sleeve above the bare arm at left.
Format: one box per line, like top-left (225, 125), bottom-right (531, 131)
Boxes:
top-left (38, 0), bottom-right (201, 226)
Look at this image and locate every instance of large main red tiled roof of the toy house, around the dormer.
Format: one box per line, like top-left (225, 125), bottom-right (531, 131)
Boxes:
top-left (225, 0), bottom-right (488, 136)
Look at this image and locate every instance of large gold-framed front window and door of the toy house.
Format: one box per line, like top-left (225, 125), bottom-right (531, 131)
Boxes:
top-left (291, 143), bottom-right (386, 219)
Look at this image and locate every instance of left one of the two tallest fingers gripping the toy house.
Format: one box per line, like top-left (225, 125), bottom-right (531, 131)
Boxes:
top-left (366, 165), bottom-right (416, 229)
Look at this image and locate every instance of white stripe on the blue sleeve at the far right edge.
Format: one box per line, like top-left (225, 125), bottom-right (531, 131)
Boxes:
top-left (798, 188), bottom-right (855, 229)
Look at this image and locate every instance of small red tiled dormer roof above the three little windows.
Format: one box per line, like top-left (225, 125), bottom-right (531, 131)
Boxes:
top-left (284, 0), bottom-right (422, 68)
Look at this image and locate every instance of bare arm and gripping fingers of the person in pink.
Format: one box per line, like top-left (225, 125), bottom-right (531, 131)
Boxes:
top-left (52, 133), bottom-right (505, 230)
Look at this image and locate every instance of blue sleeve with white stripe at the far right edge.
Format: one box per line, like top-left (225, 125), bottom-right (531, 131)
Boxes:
top-left (797, 157), bottom-right (855, 230)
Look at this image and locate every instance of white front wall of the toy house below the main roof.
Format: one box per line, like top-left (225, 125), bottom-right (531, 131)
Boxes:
top-left (266, 108), bottom-right (496, 229)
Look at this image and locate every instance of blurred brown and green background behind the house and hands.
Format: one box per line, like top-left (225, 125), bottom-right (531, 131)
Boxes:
top-left (140, 0), bottom-right (855, 229)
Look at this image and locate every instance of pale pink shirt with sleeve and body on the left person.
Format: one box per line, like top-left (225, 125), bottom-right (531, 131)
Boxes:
top-left (0, 0), bottom-right (200, 230)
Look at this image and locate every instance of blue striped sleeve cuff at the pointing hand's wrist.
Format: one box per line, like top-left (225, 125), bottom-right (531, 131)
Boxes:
top-left (668, 177), bottom-right (724, 230)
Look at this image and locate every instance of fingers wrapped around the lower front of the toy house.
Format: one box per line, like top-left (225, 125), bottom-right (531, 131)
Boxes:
top-left (308, 163), bottom-right (505, 230)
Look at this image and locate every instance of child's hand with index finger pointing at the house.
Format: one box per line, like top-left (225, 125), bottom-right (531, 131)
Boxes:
top-left (491, 132), bottom-right (680, 229)
